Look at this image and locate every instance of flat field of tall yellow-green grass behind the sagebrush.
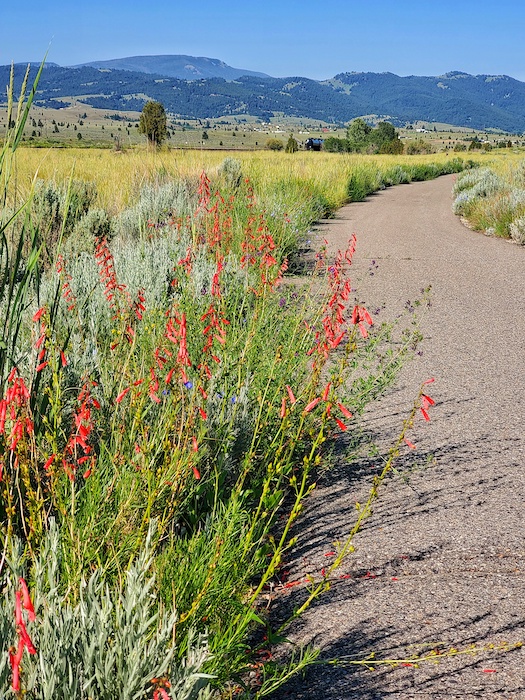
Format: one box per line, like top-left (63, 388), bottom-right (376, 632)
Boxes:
top-left (13, 148), bottom-right (496, 213)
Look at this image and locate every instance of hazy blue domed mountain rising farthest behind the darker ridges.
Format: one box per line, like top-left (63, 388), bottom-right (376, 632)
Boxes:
top-left (73, 55), bottom-right (270, 80)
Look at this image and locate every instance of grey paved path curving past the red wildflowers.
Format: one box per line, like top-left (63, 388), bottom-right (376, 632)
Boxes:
top-left (276, 176), bottom-right (525, 700)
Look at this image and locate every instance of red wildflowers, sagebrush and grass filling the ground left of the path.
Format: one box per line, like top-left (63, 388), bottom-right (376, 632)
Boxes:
top-left (0, 63), bottom-right (484, 700)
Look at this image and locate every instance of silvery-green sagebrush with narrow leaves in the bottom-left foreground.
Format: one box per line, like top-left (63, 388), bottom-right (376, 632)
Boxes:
top-left (0, 527), bottom-right (211, 700)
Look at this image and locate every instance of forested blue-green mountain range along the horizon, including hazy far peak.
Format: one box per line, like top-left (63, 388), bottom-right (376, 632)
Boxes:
top-left (4, 56), bottom-right (525, 133)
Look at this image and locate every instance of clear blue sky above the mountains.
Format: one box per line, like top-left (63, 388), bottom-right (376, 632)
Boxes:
top-left (0, 0), bottom-right (525, 81)
